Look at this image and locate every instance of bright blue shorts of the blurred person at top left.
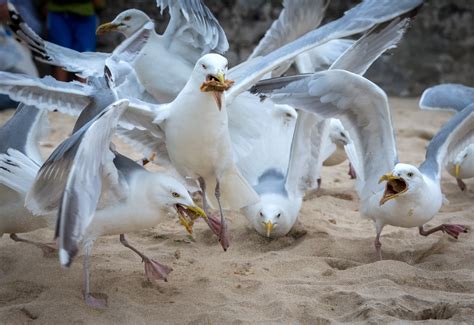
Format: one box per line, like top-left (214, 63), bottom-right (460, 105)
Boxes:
top-left (48, 12), bottom-right (97, 52)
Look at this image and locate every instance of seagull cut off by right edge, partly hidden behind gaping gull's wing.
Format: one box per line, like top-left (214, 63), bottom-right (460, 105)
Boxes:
top-left (420, 84), bottom-right (474, 191)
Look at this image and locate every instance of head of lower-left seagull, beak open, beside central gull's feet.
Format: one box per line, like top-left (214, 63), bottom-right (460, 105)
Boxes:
top-left (152, 175), bottom-right (207, 234)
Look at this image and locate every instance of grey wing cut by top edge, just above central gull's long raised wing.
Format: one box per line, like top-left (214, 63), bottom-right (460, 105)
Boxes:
top-left (249, 0), bottom-right (329, 58)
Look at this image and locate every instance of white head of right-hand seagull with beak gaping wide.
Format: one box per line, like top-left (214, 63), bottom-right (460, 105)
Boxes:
top-left (379, 164), bottom-right (424, 205)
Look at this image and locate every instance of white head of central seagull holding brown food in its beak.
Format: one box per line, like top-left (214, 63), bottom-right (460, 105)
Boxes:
top-left (196, 53), bottom-right (234, 110)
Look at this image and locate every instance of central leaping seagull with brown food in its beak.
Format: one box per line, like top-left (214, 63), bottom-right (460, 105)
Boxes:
top-left (1, 0), bottom-right (422, 249)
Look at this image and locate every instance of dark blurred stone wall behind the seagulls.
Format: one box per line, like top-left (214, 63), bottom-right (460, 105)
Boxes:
top-left (0, 0), bottom-right (474, 96)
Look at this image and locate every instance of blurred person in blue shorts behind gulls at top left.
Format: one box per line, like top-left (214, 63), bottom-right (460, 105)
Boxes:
top-left (47, 0), bottom-right (105, 81)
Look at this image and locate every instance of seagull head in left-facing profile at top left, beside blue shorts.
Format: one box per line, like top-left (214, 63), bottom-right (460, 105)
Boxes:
top-left (96, 9), bottom-right (151, 37)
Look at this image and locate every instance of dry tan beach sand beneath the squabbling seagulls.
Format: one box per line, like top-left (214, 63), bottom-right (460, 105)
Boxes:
top-left (0, 99), bottom-right (474, 324)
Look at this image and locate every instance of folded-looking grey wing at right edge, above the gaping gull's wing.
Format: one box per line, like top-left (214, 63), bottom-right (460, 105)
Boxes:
top-left (420, 84), bottom-right (474, 112)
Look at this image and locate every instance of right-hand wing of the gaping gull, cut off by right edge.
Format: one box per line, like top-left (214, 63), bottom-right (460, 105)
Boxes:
top-left (420, 103), bottom-right (474, 180)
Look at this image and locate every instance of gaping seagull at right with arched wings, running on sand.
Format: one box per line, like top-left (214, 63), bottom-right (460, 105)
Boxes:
top-left (248, 70), bottom-right (474, 260)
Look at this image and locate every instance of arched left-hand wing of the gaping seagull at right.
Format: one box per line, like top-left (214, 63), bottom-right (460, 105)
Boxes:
top-left (252, 70), bottom-right (397, 198)
